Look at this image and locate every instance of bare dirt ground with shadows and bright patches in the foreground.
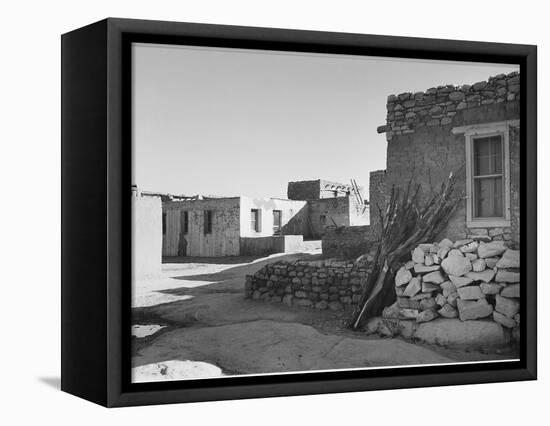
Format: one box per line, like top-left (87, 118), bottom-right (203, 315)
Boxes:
top-left (132, 252), bottom-right (516, 382)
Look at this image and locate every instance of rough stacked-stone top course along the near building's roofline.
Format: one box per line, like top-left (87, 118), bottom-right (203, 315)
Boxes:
top-left (378, 72), bottom-right (520, 141)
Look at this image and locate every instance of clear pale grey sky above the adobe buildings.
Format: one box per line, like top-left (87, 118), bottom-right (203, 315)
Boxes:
top-left (132, 44), bottom-right (518, 198)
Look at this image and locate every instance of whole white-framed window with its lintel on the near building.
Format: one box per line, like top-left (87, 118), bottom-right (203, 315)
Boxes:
top-left (452, 120), bottom-right (519, 228)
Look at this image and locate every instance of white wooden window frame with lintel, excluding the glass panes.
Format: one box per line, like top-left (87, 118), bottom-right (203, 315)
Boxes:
top-left (452, 120), bottom-right (519, 228)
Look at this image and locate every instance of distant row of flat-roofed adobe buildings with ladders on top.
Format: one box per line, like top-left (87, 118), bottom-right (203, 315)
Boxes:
top-left (162, 180), bottom-right (369, 257)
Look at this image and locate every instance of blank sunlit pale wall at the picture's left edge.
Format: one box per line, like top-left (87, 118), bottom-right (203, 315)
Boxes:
top-left (132, 195), bottom-right (162, 281)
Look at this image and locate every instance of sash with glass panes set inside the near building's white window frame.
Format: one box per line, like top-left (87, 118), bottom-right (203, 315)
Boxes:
top-left (472, 135), bottom-right (504, 218)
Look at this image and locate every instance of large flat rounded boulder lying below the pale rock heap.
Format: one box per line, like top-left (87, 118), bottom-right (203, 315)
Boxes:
top-left (414, 318), bottom-right (510, 348)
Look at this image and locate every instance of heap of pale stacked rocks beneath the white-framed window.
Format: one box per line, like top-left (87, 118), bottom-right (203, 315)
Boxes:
top-left (383, 237), bottom-right (520, 332)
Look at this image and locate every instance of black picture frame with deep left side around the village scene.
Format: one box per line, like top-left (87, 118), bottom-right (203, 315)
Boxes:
top-left (61, 18), bottom-right (537, 407)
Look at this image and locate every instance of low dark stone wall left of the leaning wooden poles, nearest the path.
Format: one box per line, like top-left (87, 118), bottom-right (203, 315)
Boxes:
top-left (245, 259), bottom-right (371, 310)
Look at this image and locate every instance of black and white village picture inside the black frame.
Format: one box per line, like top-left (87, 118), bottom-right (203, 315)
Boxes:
top-left (132, 42), bottom-right (524, 383)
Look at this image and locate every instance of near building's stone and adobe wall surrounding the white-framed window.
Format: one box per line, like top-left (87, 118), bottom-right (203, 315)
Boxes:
top-left (378, 73), bottom-right (520, 243)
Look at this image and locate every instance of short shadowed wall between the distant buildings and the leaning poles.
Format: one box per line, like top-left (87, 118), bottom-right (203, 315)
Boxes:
top-left (323, 225), bottom-right (378, 259)
